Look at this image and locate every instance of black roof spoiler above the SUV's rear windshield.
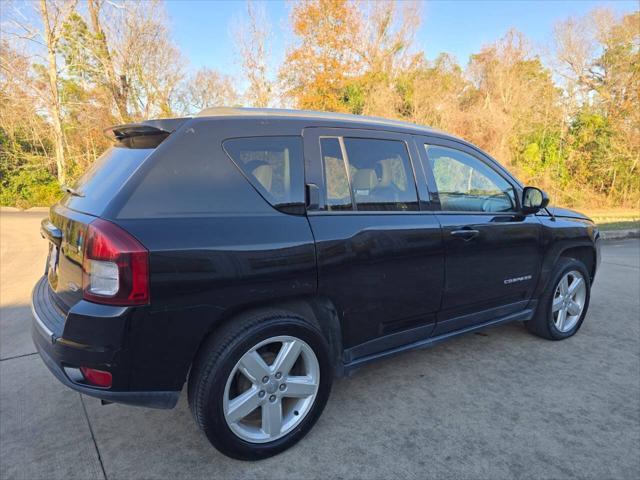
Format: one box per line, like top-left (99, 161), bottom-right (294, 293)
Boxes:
top-left (104, 118), bottom-right (188, 148)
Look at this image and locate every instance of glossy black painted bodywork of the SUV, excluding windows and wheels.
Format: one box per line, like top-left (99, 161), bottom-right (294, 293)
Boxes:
top-left (33, 114), bottom-right (599, 406)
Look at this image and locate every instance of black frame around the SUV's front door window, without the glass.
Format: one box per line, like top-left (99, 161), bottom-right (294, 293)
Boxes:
top-left (416, 136), bottom-right (522, 217)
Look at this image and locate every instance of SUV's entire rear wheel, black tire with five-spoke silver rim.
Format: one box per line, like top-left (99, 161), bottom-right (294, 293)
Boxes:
top-left (188, 311), bottom-right (333, 460)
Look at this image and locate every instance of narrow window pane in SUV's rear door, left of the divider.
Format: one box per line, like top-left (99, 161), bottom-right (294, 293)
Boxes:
top-left (320, 138), bottom-right (353, 210)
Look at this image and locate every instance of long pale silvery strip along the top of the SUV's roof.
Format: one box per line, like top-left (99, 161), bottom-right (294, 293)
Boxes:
top-left (196, 107), bottom-right (453, 137)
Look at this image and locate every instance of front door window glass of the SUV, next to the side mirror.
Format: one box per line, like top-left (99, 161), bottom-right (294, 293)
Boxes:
top-left (425, 145), bottom-right (516, 212)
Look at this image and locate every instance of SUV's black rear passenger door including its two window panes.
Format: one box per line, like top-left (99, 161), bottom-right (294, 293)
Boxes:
top-left (303, 128), bottom-right (444, 362)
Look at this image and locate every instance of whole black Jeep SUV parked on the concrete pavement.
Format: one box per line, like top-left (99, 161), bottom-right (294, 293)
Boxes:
top-left (32, 108), bottom-right (600, 459)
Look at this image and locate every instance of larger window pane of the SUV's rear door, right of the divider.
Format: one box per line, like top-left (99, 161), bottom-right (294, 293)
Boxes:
top-left (344, 138), bottom-right (418, 211)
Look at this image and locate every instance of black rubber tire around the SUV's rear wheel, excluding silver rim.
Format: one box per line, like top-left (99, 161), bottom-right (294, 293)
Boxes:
top-left (200, 318), bottom-right (332, 460)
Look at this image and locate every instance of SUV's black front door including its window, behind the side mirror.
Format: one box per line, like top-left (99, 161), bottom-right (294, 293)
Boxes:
top-left (418, 133), bottom-right (542, 335)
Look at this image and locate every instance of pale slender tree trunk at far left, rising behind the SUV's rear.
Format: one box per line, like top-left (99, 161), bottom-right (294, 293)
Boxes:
top-left (40, 0), bottom-right (67, 185)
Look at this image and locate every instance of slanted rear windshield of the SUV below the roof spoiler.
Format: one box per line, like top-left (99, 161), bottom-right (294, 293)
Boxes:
top-left (63, 147), bottom-right (154, 215)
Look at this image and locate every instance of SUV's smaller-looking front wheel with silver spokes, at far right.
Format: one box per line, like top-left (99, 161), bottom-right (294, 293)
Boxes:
top-left (525, 257), bottom-right (591, 340)
